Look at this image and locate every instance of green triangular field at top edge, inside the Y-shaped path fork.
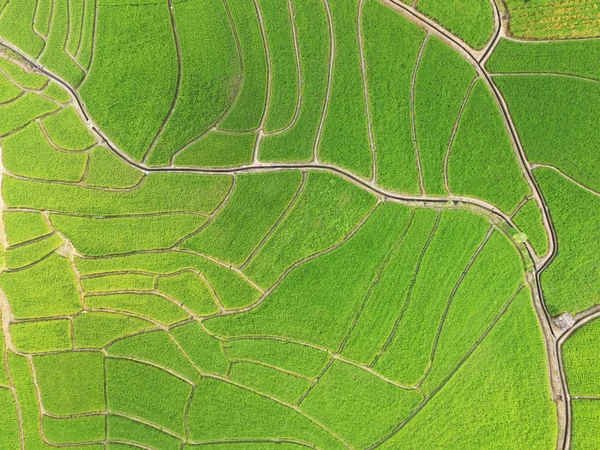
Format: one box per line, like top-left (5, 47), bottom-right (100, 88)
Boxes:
top-left (417, 0), bottom-right (494, 50)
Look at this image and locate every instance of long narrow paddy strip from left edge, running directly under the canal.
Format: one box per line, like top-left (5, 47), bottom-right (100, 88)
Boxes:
top-left (2, 173), bottom-right (232, 215)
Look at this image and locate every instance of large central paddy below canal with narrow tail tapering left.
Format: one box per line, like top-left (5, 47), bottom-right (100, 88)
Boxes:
top-left (205, 203), bottom-right (408, 351)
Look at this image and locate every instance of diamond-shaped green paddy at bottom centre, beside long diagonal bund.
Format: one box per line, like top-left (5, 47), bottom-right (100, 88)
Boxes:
top-left (301, 361), bottom-right (422, 448)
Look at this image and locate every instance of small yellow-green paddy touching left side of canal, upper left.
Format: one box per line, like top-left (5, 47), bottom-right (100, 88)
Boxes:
top-left (42, 106), bottom-right (96, 150)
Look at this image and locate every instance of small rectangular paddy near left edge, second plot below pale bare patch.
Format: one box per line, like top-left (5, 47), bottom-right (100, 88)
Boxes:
top-left (10, 319), bottom-right (72, 353)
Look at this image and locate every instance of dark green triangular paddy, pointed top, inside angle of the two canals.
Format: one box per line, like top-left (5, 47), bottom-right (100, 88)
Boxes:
top-left (448, 81), bottom-right (530, 212)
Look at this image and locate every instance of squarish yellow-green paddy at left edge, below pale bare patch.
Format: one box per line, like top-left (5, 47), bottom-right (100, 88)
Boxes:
top-left (0, 254), bottom-right (81, 319)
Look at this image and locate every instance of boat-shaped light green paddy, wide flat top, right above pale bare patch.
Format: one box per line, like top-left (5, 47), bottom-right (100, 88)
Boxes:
top-left (50, 214), bottom-right (207, 256)
